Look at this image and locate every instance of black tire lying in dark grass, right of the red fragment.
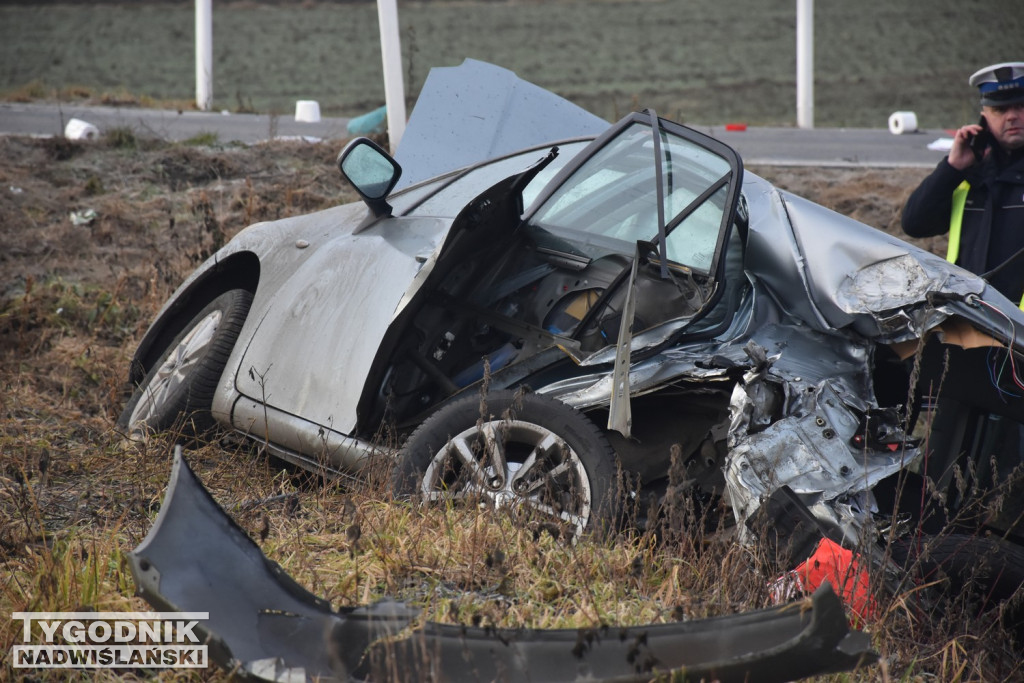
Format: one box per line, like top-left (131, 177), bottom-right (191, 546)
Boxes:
top-left (889, 533), bottom-right (1024, 637)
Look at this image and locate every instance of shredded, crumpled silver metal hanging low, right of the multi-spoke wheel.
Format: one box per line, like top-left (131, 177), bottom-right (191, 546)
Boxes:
top-left (724, 326), bottom-right (919, 542)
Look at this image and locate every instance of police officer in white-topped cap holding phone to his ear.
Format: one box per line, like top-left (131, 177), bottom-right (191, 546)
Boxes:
top-left (903, 61), bottom-right (1024, 303)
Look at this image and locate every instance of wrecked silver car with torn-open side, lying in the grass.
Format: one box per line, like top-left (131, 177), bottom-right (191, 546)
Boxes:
top-left (121, 61), bottom-right (1024, 598)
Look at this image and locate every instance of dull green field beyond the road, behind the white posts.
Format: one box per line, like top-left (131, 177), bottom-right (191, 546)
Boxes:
top-left (0, 0), bottom-right (1024, 129)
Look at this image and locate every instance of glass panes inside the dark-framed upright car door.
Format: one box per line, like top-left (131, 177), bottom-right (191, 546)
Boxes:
top-left (530, 122), bottom-right (731, 272)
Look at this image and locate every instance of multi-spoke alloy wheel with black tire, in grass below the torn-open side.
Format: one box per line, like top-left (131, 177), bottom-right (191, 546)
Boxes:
top-left (392, 391), bottom-right (620, 540)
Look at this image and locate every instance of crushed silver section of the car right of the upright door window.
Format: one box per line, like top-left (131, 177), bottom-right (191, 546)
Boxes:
top-left (539, 167), bottom-right (1024, 547)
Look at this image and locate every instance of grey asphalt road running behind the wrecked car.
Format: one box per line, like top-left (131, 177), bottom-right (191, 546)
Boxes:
top-left (0, 102), bottom-right (949, 168)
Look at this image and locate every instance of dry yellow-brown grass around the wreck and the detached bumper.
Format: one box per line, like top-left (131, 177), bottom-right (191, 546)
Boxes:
top-left (0, 133), bottom-right (1020, 680)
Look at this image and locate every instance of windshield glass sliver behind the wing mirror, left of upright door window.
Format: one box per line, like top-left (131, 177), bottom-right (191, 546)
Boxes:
top-left (410, 140), bottom-right (589, 217)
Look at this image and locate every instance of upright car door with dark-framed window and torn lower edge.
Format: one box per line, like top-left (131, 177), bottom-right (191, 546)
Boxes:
top-left (526, 112), bottom-right (742, 341)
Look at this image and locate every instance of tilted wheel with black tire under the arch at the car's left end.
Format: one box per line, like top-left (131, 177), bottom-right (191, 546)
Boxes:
top-left (118, 290), bottom-right (253, 438)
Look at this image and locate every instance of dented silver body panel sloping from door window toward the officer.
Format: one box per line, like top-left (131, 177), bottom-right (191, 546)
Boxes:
top-left (743, 173), bottom-right (1024, 344)
